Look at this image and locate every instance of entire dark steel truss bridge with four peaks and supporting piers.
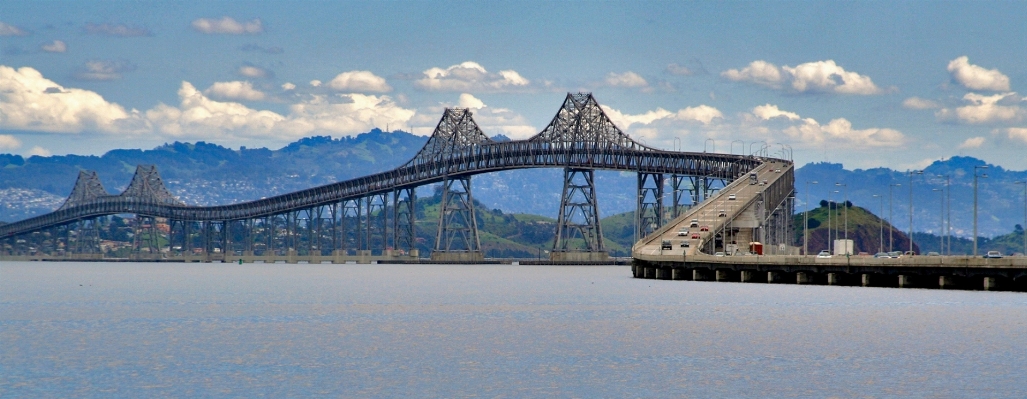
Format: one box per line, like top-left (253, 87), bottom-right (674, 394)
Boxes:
top-left (0, 93), bottom-right (784, 262)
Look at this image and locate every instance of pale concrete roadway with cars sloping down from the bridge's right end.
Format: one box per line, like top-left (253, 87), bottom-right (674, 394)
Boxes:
top-left (632, 156), bottom-right (794, 256)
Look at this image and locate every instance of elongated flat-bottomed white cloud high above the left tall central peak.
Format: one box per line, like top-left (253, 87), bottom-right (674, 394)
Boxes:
top-left (414, 61), bottom-right (531, 92)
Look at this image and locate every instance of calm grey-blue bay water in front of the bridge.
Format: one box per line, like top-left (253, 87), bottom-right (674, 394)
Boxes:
top-left (0, 262), bottom-right (1027, 398)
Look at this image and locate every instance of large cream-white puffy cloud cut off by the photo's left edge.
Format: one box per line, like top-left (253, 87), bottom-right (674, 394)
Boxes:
top-left (0, 66), bottom-right (137, 133)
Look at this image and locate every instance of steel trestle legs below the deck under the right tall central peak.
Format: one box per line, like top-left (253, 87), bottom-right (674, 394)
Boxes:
top-left (549, 167), bottom-right (609, 262)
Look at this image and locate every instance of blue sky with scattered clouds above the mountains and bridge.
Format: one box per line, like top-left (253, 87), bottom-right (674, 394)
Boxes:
top-left (0, 0), bottom-right (1027, 170)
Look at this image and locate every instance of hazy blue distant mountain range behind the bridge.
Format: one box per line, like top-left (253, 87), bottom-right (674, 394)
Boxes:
top-left (0, 129), bottom-right (1027, 237)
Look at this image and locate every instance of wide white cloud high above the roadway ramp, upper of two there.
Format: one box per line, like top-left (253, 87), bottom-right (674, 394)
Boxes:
top-left (720, 59), bottom-right (883, 95)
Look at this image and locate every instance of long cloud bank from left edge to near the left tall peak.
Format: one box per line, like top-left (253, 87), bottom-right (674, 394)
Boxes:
top-left (0, 66), bottom-right (416, 142)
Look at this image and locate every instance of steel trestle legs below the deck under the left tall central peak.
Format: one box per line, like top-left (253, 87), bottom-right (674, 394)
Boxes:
top-left (431, 176), bottom-right (485, 262)
